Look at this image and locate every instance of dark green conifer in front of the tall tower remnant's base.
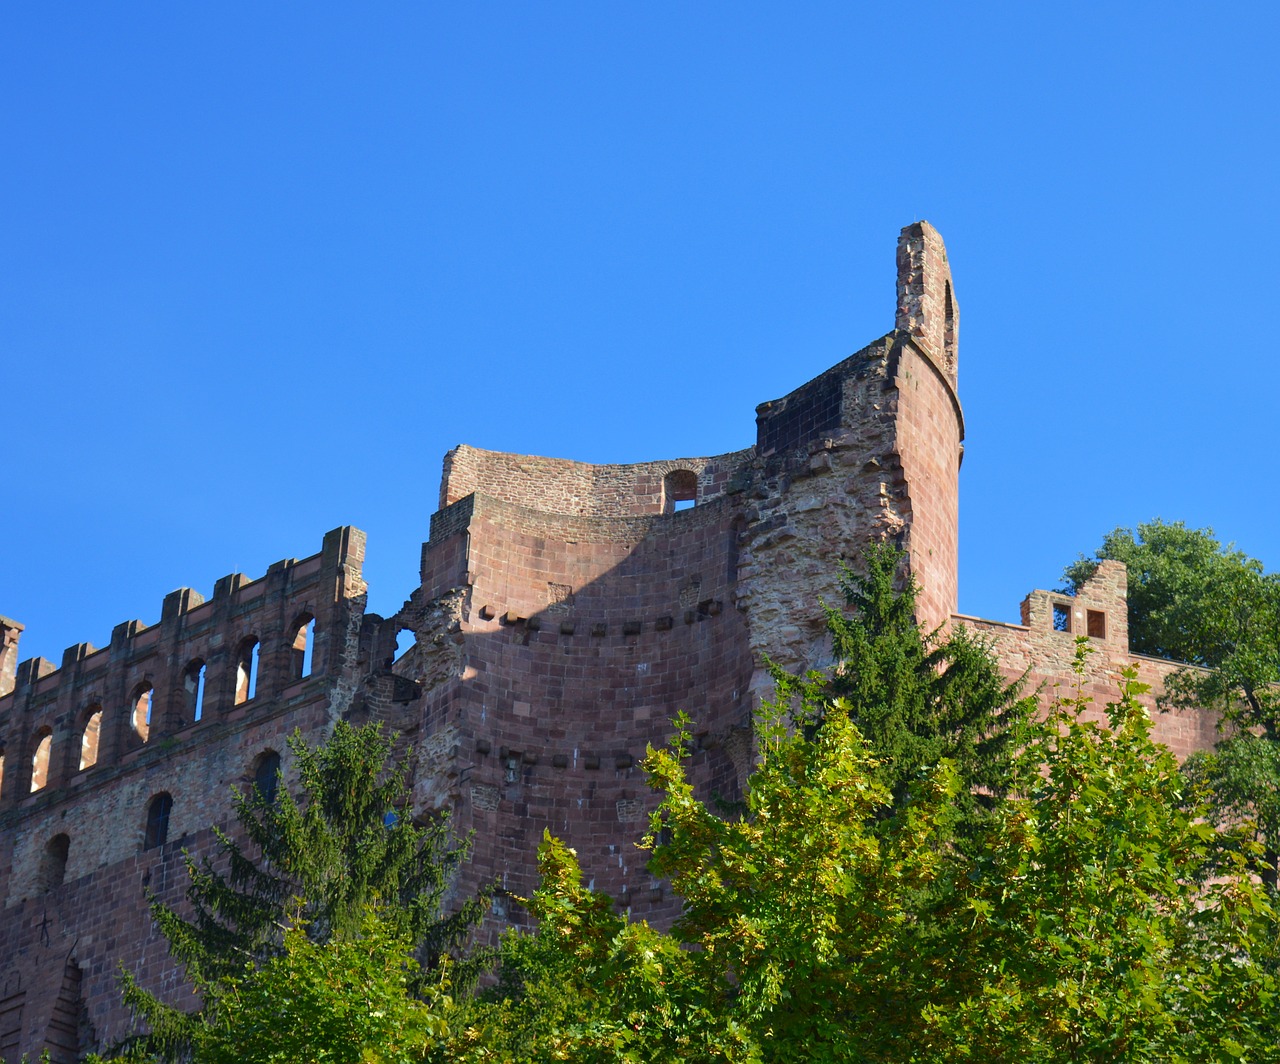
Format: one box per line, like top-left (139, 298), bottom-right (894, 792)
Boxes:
top-left (824, 544), bottom-right (1036, 812)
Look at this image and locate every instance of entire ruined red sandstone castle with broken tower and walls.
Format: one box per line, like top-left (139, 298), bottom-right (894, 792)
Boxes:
top-left (0, 223), bottom-right (1213, 1061)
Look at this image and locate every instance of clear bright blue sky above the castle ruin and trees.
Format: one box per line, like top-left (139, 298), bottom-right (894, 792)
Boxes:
top-left (0, 0), bottom-right (1280, 662)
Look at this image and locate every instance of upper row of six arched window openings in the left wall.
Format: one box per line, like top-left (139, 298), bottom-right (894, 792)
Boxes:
top-left (20, 616), bottom-right (315, 794)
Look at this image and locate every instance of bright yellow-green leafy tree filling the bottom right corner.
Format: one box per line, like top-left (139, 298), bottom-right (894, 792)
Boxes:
top-left (924, 650), bottom-right (1280, 1064)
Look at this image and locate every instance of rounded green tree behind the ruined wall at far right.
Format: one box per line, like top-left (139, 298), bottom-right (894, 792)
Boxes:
top-left (1065, 521), bottom-right (1280, 889)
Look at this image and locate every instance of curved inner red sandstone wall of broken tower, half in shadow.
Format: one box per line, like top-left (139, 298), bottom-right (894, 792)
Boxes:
top-left (404, 496), bottom-right (751, 917)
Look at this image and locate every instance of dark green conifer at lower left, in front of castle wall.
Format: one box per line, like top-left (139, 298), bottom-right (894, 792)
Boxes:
top-left (110, 722), bottom-right (490, 1060)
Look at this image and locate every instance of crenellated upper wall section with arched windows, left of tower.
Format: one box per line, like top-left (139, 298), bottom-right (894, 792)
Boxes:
top-left (0, 528), bottom-right (365, 810)
